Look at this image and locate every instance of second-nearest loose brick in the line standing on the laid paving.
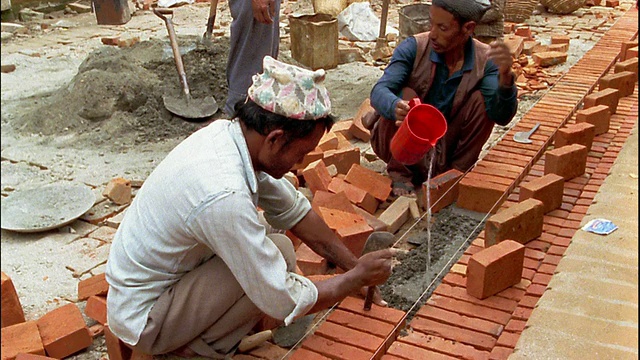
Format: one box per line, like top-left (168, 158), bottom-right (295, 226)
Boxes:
top-left (484, 198), bottom-right (544, 247)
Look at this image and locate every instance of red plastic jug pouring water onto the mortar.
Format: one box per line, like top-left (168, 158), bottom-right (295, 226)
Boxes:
top-left (390, 98), bottom-right (447, 165)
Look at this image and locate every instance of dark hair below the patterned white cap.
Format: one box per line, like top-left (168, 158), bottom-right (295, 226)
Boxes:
top-left (235, 99), bottom-right (336, 144)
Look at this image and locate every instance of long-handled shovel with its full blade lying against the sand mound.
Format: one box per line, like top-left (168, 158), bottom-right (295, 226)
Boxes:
top-left (153, 8), bottom-right (218, 119)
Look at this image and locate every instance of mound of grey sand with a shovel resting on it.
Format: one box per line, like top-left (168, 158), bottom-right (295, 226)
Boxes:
top-left (17, 37), bottom-right (229, 146)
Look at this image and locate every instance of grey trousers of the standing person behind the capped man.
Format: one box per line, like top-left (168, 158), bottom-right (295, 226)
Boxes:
top-left (224, 0), bottom-right (280, 116)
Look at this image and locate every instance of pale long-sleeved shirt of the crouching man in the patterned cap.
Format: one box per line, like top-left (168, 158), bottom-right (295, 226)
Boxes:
top-left (106, 120), bottom-right (318, 345)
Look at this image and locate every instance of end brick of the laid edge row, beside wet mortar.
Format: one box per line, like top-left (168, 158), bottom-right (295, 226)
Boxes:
top-left (456, 177), bottom-right (509, 213)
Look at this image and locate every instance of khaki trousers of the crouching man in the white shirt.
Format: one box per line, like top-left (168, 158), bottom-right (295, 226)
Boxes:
top-left (135, 233), bottom-right (296, 359)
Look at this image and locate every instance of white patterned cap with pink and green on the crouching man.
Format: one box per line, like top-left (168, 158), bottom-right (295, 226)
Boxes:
top-left (248, 56), bottom-right (331, 120)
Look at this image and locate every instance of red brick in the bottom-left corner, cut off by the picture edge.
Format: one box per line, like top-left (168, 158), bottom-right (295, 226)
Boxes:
top-left (0, 321), bottom-right (45, 360)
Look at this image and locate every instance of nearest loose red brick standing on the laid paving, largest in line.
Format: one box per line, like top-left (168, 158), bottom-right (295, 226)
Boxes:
top-left (467, 240), bottom-right (525, 299)
